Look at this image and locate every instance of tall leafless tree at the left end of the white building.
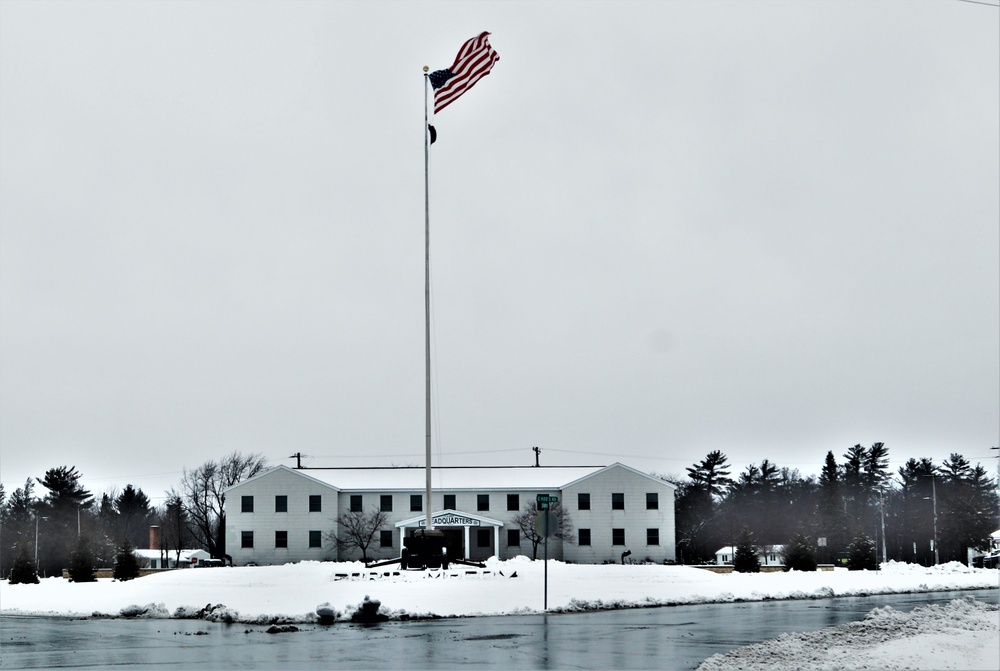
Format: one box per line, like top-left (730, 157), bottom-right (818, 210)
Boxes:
top-left (181, 452), bottom-right (267, 559)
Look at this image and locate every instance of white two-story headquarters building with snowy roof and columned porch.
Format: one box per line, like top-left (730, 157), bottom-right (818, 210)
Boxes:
top-left (226, 463), bottom-right (676, 566)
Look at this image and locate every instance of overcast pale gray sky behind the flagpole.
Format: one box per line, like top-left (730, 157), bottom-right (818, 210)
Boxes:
top-left (0, 0), bottom-right (1000, 498)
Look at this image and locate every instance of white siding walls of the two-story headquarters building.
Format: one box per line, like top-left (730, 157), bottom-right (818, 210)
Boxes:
top-left (226, 464), bottom-right (675, 565)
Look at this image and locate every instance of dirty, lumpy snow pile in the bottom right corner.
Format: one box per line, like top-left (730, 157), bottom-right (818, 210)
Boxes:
top-left (698, 598), bottom-right (1000, 671)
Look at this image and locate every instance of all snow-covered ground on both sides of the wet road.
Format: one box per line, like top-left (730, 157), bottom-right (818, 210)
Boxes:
top-left (0, 557), bottom-right (1000, 669)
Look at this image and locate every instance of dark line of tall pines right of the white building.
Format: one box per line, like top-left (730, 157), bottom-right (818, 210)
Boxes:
top-left (663, 443), bottom-right (1000, 565)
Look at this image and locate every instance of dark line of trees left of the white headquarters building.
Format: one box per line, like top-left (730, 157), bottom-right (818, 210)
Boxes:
top-left (0, 452), bottom-right (267, 577)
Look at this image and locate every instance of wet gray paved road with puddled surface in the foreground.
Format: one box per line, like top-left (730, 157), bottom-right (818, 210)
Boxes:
top-left (0, 590), bottom-right (998, 670)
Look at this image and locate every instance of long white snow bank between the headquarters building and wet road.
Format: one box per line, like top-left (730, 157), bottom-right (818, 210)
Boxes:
top-left (0, 557), bottom-right (1000, 623)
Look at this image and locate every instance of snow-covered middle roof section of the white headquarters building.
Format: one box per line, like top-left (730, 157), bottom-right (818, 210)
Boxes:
top-left (280, 466), bottom-right (605, 492)
